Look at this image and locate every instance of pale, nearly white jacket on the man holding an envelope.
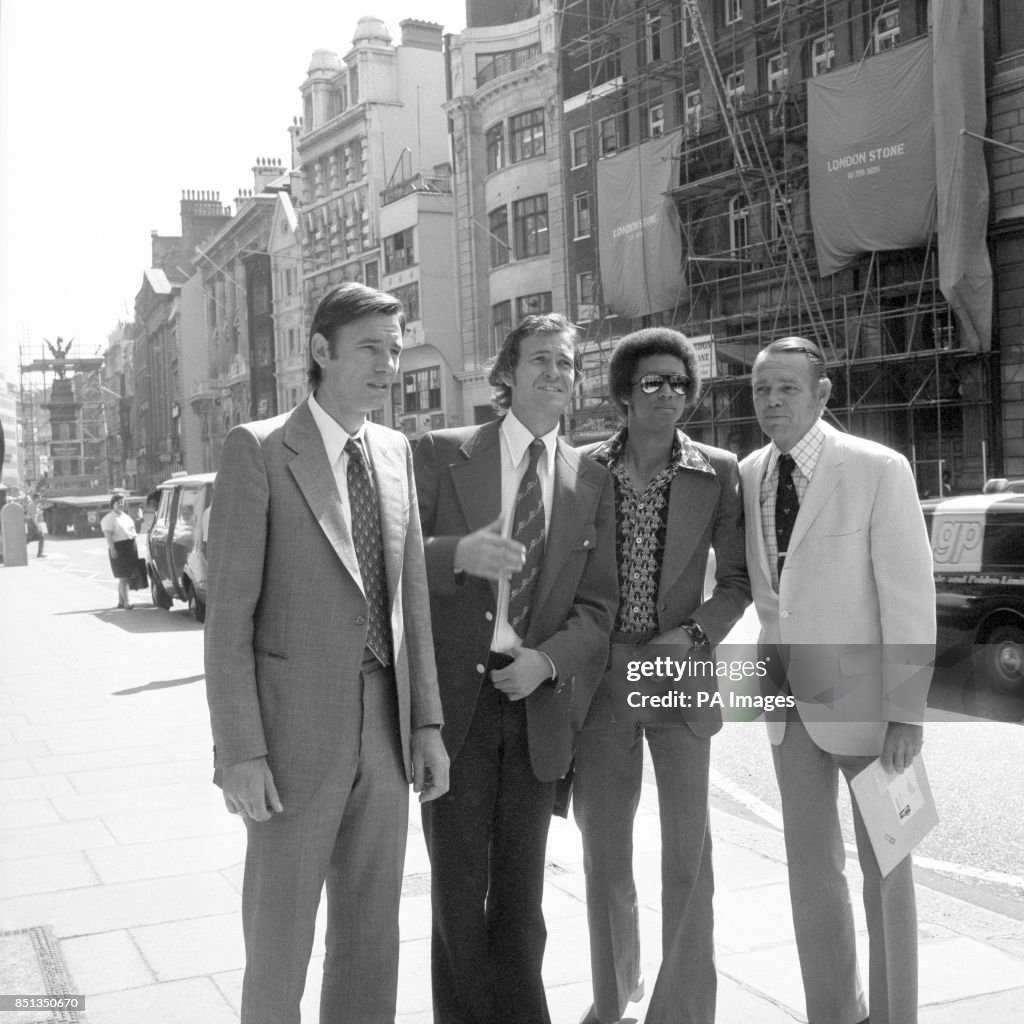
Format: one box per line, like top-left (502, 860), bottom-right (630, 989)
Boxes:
top-left (739, 423), bottom-right (935, 755)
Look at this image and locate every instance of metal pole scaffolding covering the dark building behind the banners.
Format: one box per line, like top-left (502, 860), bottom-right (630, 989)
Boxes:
top-left (561, 0), bottom-right (997, 494)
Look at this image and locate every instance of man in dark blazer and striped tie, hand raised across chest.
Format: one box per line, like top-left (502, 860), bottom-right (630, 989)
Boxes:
top-left (415, 314), bottom-right (618, 1024)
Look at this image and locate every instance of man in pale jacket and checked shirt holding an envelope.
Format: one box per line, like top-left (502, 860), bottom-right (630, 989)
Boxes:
top-left (740, 338), bottom-right (935, 1024)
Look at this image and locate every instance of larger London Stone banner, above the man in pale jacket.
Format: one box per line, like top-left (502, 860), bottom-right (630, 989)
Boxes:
top-left (807, 38), bottom-right (936, 276)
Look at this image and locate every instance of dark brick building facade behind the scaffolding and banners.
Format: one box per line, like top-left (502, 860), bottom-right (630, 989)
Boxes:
top-left (560, 0), bottom-right (1024, 494)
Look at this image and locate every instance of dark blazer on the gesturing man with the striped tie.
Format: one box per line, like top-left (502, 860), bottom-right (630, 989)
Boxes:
top-left (414, 421), bottom-right (618, 781)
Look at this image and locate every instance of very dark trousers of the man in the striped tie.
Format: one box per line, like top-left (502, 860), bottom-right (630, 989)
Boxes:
top-left (423, 675), bottom-right (555, 1024)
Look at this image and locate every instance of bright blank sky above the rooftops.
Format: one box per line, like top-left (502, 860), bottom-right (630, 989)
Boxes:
top-left (0, 0), bottom-right (466, 381)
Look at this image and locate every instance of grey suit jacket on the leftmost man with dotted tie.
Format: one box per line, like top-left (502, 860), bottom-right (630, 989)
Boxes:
top-left (206, 402), bottom-right (441, 811)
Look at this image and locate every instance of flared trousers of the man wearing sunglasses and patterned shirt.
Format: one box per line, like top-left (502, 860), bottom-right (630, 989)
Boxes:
top-left (573, 721), bottom-right (718, 1024)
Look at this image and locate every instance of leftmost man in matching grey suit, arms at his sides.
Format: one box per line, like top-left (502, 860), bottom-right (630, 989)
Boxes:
top-left (206, 284), bottom-right (447, 1024)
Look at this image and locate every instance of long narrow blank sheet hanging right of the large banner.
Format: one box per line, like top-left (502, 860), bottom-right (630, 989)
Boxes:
top-left (934, 0), bottom-right (992, 352)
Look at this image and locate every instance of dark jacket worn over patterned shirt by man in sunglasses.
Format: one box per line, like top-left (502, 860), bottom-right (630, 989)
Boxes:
top-left (580, 431), bottom-right (751, 735)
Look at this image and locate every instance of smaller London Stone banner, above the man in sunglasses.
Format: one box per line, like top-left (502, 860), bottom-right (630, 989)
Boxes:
top-left (597, 132), bottom-right (682, 316)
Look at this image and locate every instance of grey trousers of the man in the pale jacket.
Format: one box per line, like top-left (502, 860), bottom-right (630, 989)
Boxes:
top-left (772, 709), bottom-right (918, 1024)
